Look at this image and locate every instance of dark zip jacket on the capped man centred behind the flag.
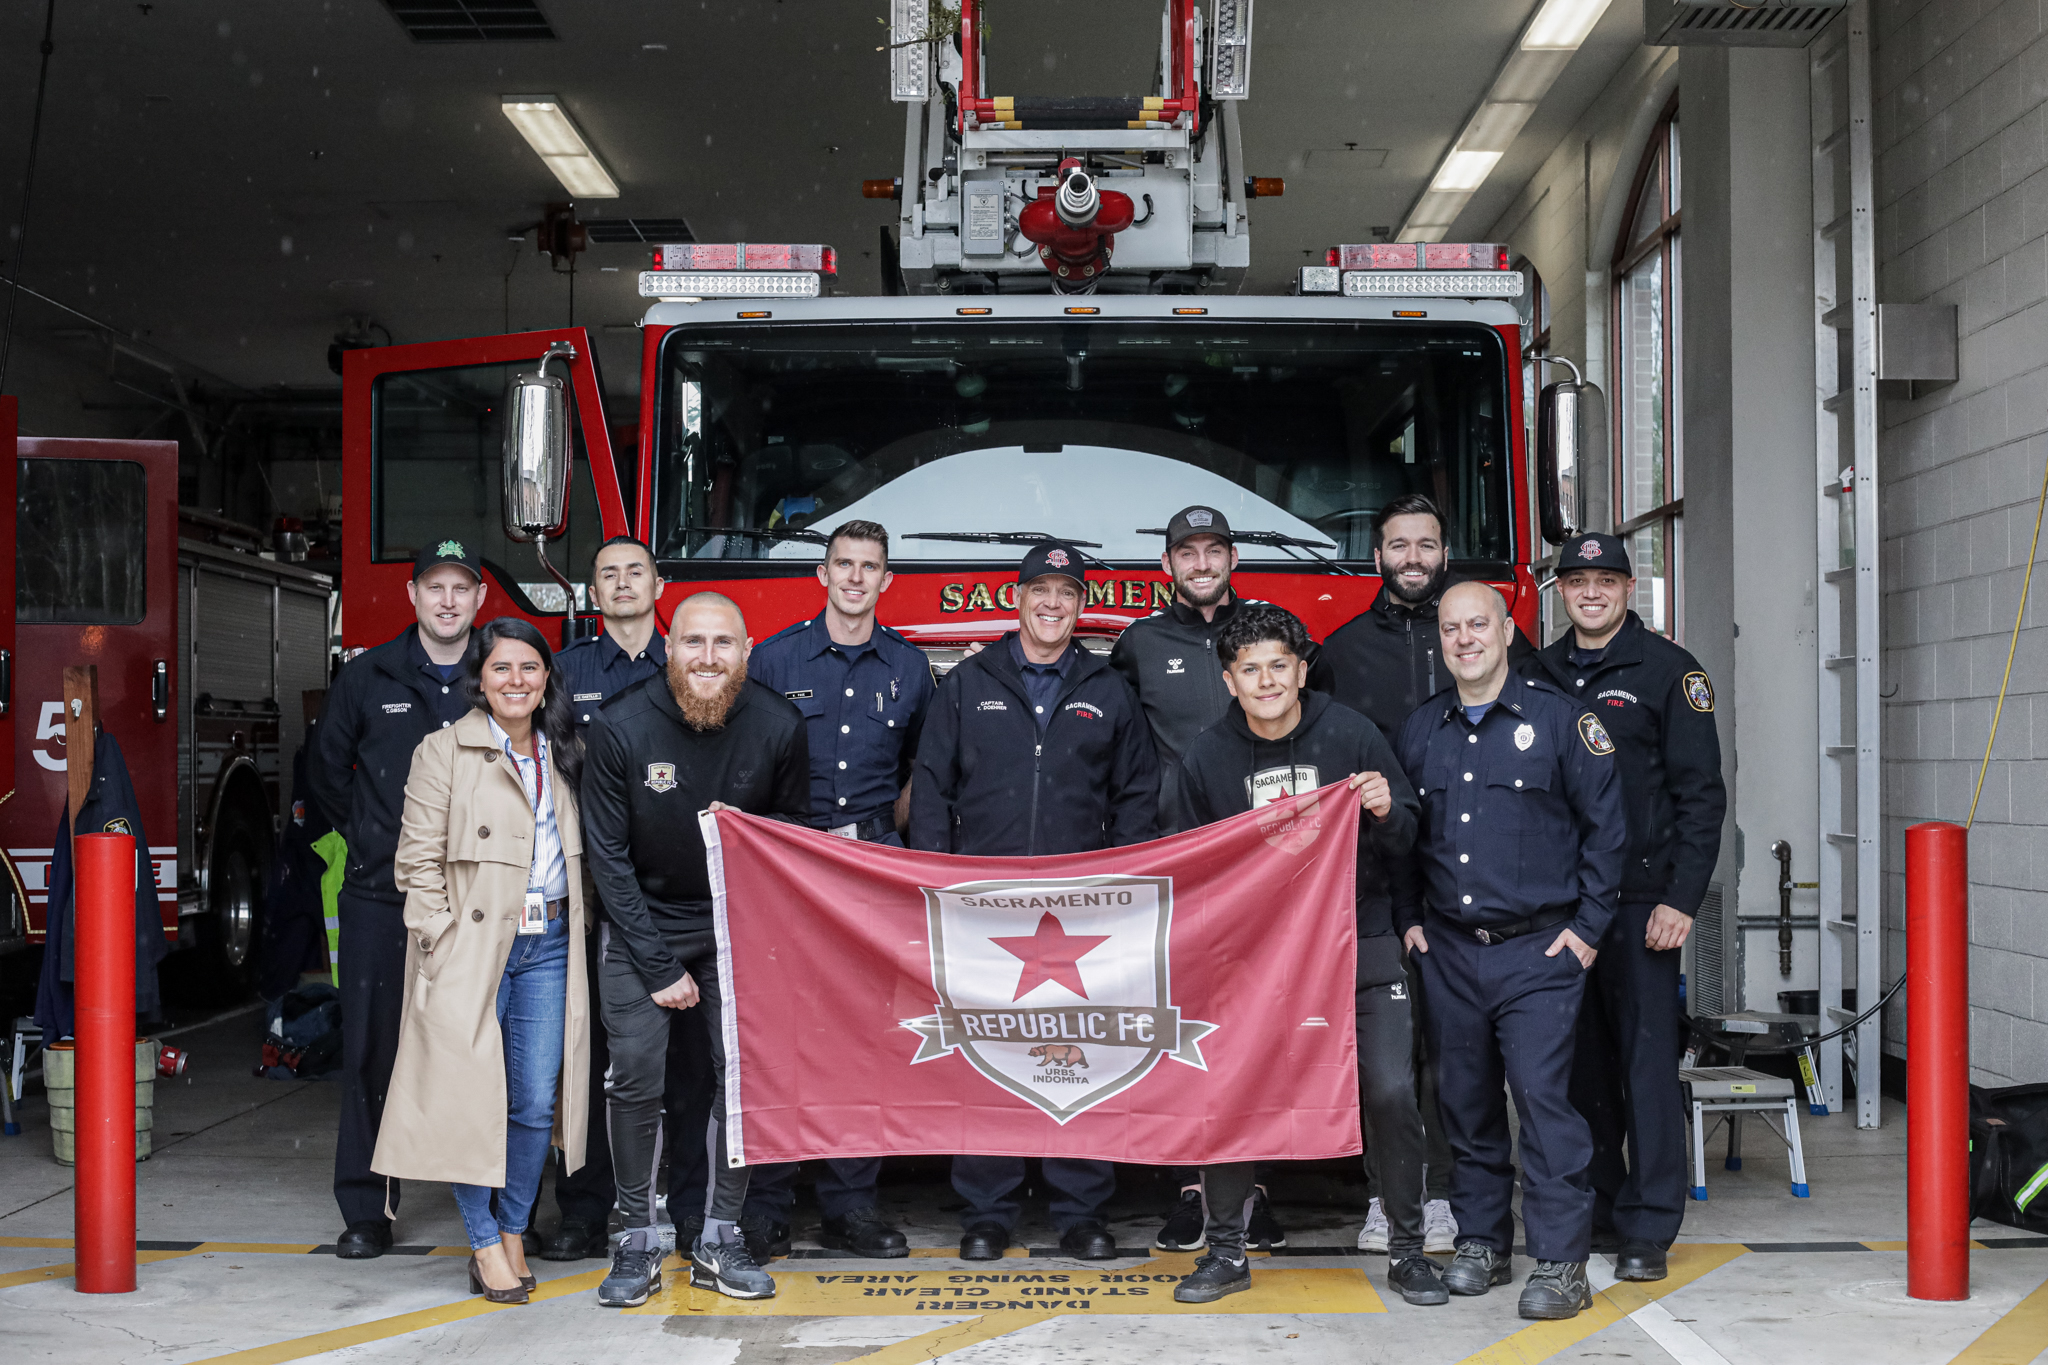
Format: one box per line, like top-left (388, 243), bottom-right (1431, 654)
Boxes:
top-left (905, 630), bottom-right (1159, 857)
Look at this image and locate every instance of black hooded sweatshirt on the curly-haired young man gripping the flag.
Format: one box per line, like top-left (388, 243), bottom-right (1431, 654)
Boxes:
top-left (1180, 692), bottom-right (1421, 986)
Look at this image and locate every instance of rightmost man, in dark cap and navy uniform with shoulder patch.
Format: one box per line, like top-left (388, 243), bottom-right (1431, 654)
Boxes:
top-left (1522, 534), bottom-right (1729, 1279)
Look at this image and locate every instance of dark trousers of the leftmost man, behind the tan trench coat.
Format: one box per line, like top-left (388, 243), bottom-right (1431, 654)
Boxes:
top-left (334, 888), bottom-right (406, 1224)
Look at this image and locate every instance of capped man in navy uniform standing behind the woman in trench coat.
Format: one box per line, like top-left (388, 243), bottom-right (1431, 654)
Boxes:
top-left (305, 538), bottom-right (487, 1261)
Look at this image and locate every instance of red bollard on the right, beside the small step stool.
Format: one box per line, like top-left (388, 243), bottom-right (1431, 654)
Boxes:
top-left (1900, 821), bottom-right (1970, 1300)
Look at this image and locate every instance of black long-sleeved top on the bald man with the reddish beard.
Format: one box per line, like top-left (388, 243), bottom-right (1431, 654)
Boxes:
top-left (582, 673), bottom-right (811, 995)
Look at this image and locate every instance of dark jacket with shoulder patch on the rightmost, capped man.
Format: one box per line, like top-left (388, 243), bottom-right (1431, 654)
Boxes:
top-left (1522, 612), bottom-right (1729, 915)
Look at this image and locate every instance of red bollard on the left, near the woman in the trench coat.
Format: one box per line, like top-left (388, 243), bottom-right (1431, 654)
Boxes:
top-left (72, 835), bottom-right (135, 1293)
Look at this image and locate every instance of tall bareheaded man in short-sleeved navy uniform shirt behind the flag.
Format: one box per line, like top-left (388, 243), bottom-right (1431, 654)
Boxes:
top-left (741, 522), bottom-right (934, 1259)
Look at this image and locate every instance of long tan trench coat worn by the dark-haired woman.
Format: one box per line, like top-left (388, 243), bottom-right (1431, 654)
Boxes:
top-left (371, 710), bottom-right (590, 1189)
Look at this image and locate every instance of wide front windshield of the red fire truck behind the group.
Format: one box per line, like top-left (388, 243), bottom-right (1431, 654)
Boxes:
top-left (653, 319), bottom-right (1513, 561)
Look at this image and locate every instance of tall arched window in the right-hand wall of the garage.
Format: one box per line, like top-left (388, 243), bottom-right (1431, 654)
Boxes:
top-left (1614, 102), bottom-right (1686, 639)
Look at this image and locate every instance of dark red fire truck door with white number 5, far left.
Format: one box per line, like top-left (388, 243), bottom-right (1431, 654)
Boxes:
top-left (0, 431), bottom-right (182, 939)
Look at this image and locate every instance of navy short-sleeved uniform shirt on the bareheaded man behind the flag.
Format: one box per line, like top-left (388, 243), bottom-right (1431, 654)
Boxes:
top-left (748, 612), bottom-right (936, 829)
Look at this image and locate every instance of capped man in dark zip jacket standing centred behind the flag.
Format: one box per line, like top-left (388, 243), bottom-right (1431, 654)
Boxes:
top-left (907, 540), bottom-right (1159, 1261)
